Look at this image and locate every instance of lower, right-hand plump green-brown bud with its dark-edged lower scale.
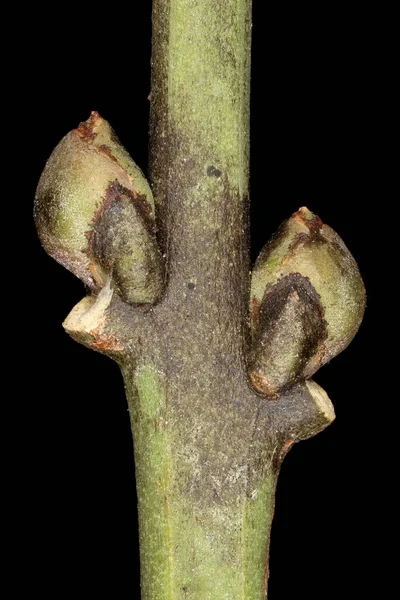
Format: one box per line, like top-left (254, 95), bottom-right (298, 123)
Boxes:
top-left (249, 208), bottom-right (365, 397)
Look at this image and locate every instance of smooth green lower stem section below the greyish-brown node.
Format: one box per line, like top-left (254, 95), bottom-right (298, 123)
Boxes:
top-left (125, 366), bottom-right (276, 600)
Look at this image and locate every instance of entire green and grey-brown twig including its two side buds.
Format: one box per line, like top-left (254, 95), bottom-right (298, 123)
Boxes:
top-left (36, 0), bottom-right (364, 600)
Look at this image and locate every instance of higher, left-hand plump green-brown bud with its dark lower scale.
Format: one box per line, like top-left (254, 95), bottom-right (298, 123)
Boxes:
top-left (35, 112), bottom-right (163, 303)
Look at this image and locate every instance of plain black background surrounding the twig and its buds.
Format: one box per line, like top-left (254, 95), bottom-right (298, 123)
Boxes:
top-left (10, 0), bottom-right (383, 600)
